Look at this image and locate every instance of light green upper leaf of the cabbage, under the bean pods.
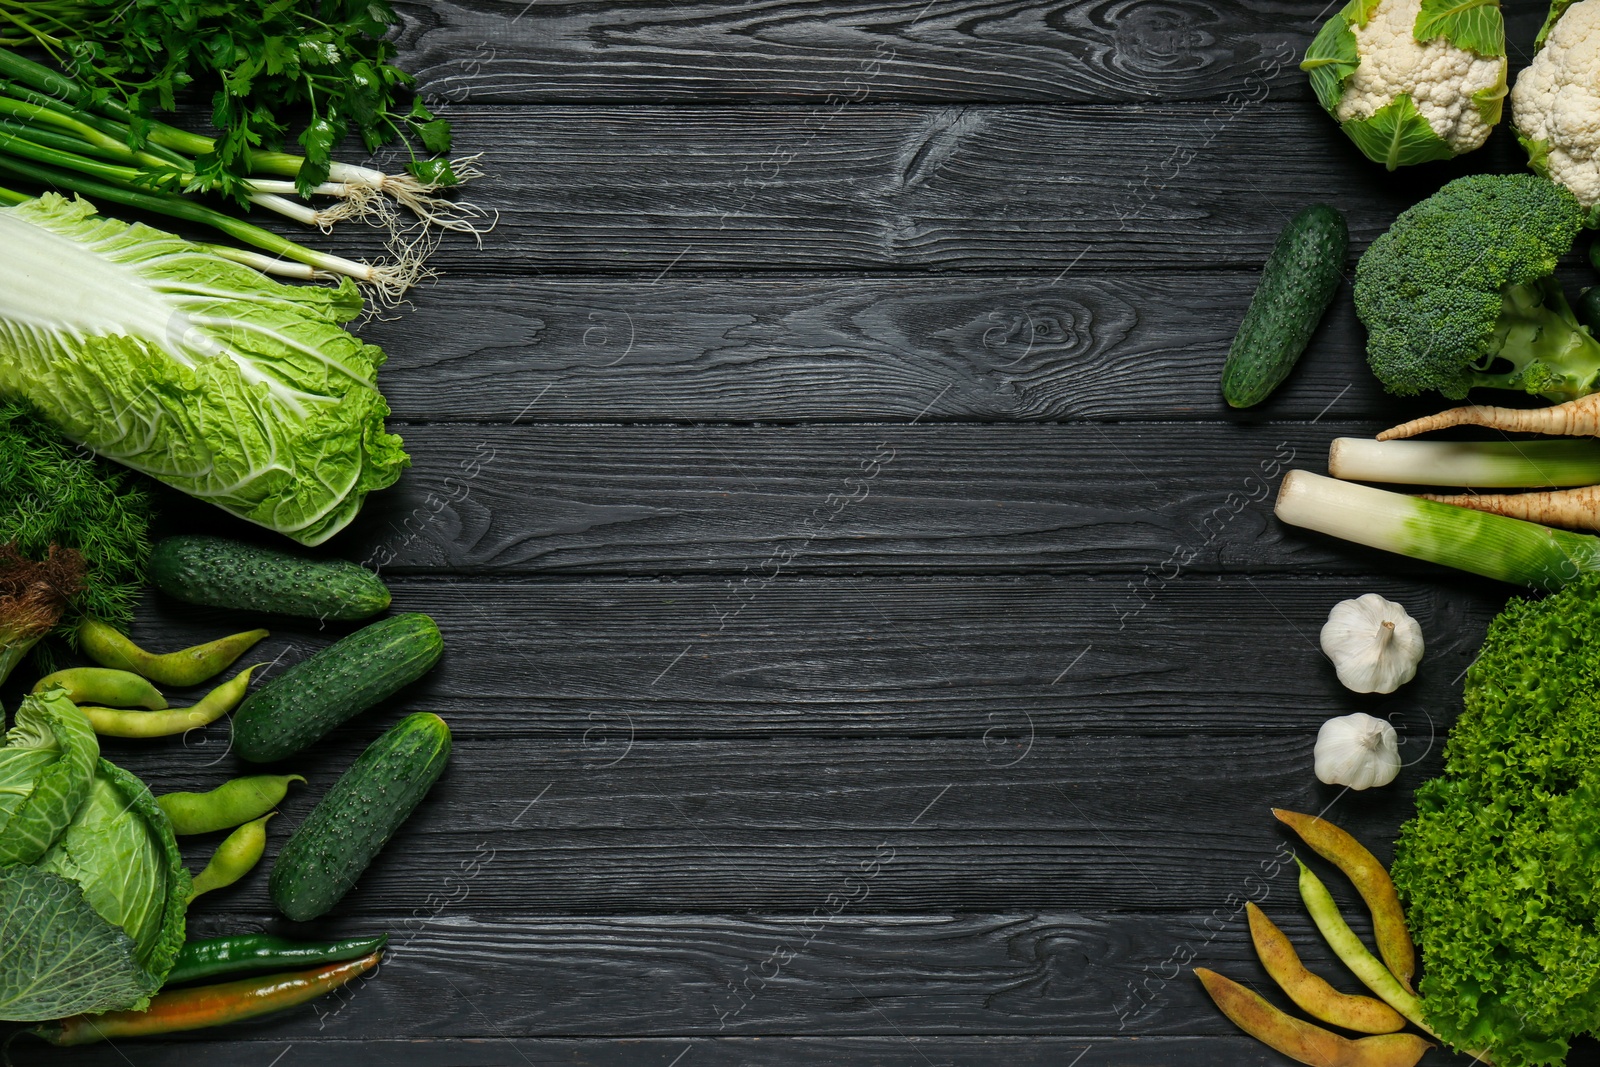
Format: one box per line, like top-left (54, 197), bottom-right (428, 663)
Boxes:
top-left (0, 689), bottom-right (99, 864)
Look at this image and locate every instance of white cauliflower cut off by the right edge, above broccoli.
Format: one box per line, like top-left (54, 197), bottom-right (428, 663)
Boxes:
top-left (1510, 0), bottom-right (1600, 208)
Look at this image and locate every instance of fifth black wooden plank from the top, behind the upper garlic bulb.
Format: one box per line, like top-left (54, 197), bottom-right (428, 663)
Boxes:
top-left (103, 576), bottom-right (1506, 742)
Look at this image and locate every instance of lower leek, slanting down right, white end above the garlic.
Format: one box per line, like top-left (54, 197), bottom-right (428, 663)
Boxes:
top-left (1275, 470), bottom-right (1600, 590)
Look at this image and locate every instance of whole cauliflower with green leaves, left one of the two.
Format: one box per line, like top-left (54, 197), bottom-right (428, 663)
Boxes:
top-left (1301, 0), bottom-right (1504, 170)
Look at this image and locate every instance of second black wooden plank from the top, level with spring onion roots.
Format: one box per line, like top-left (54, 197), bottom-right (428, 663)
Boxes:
top-left (334, 102), bottom-right (1526, 278)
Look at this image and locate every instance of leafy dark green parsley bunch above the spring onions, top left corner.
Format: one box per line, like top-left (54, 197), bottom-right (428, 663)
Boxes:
top-left (0, 0), bottom-right (456, 194)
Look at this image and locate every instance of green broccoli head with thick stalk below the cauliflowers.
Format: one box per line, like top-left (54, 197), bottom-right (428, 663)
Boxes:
top-left (1355, 174), bottom-right (1600, 400)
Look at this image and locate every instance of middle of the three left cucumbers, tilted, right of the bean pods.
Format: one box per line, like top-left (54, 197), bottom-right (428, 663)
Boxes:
top-left (234, 614), bottom-right (445, 763)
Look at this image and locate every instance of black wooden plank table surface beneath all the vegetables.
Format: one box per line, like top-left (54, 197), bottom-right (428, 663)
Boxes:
top-left (18, 0), bottom-right (1574, 1067)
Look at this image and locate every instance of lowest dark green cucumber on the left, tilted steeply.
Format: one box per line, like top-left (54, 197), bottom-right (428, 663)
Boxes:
top-left (267, 712), bottom-right (450, 923)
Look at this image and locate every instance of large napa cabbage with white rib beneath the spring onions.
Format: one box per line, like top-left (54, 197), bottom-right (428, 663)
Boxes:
top-left (0, 194), bottom-right (410, 544)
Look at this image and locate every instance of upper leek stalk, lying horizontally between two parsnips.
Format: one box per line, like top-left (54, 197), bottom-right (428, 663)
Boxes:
top-left (1328, 437), bottom-right (1600, 490)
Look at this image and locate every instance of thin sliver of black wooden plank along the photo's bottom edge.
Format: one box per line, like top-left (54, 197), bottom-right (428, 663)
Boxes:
top-left (3, 1022), bottom-right (1484, 1067)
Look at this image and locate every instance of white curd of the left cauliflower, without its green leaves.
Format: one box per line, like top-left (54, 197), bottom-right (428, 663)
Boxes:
top-left (1336, 0), bottom-right (1504, 155)
